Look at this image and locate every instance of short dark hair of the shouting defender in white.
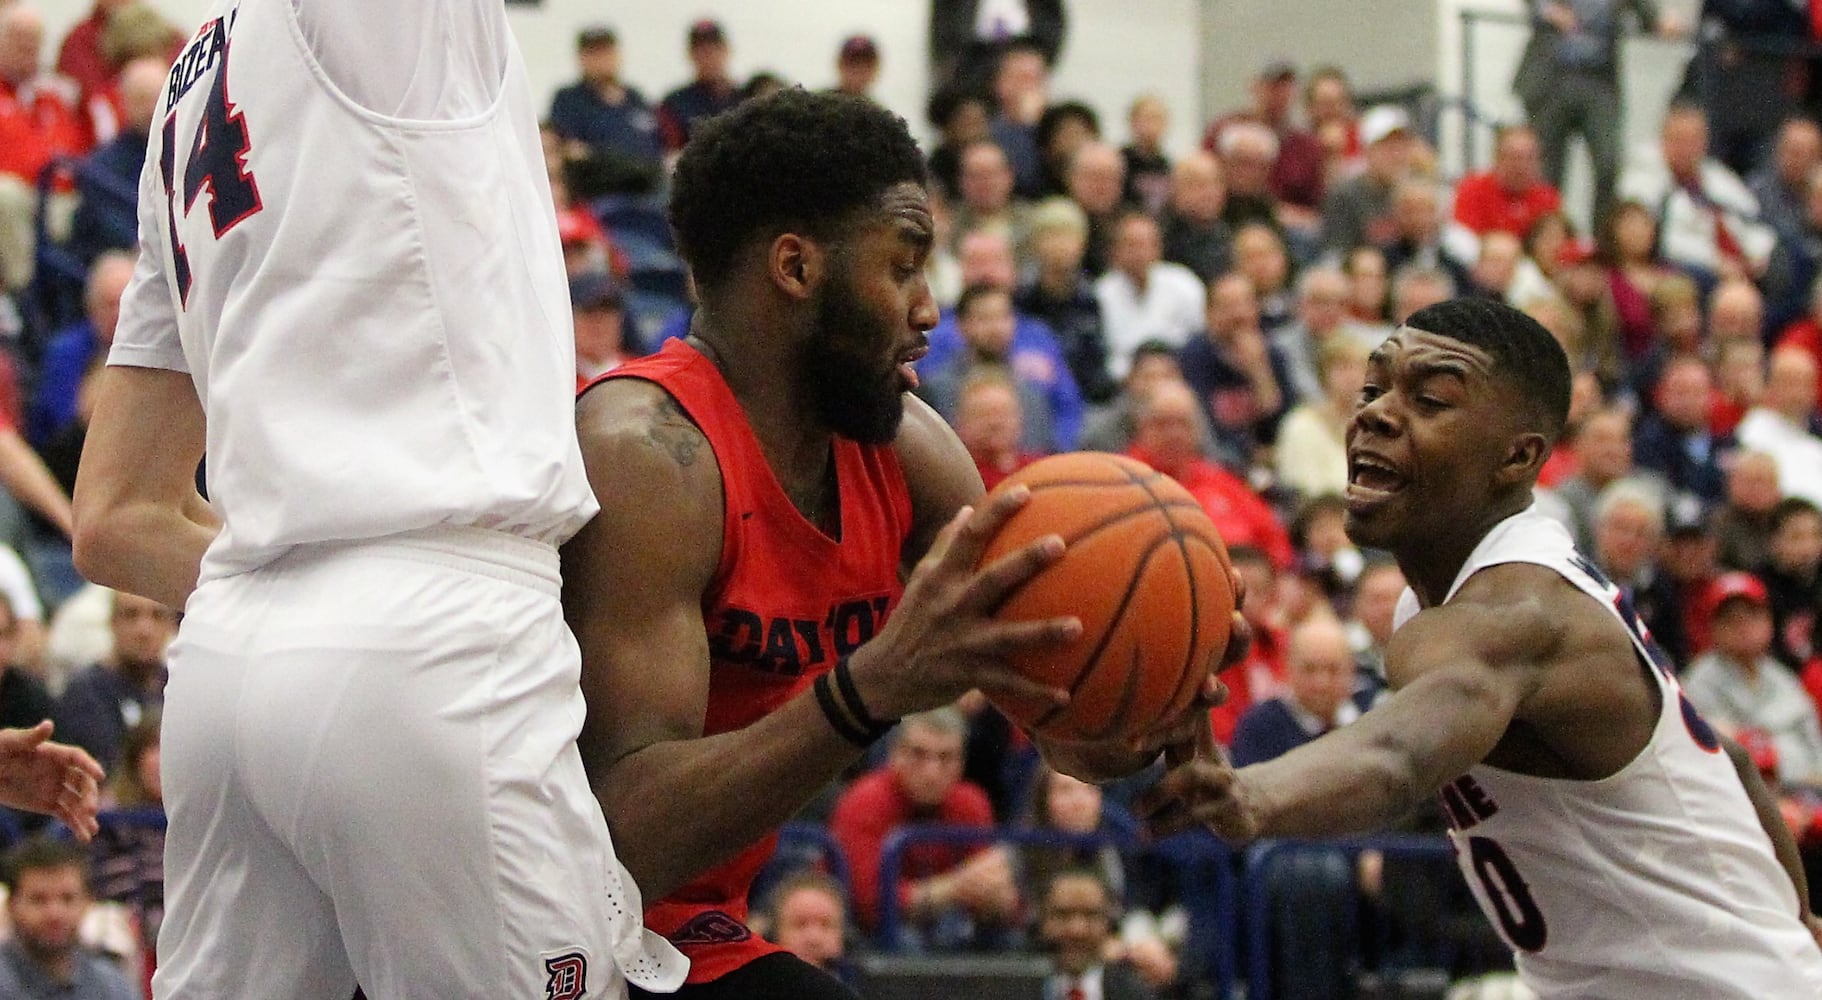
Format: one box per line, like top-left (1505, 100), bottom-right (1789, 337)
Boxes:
top-left (1405, 299), bottom-right (1572, 443)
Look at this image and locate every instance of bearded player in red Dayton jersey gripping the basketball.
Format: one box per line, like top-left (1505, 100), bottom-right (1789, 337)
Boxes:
top-left (563, 91), bottom-right (1244, 1000)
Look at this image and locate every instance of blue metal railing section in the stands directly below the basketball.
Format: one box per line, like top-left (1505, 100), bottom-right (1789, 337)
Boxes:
top-left (878, 823), bottom-right (1239, 998)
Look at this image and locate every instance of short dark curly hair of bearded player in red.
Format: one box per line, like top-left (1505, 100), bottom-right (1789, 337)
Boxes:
top-left (670, 87), bottom-right (929, 288)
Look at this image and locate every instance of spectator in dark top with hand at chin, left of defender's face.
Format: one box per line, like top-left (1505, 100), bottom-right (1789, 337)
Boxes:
top-left (1179, 271), bottom-right (1295, 460)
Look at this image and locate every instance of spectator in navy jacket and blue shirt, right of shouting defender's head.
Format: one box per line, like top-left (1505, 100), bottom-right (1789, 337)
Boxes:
top-left (1633, 355), bottom-right (1733, 505)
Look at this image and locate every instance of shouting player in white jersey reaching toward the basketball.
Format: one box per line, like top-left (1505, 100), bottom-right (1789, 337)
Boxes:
top-left (1141, 299), bottom-right (1822, 1000)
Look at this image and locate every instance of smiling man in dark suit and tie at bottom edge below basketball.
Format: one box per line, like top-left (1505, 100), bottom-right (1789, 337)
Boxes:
top-left (1039, 871), bottom-right (1157, 1000)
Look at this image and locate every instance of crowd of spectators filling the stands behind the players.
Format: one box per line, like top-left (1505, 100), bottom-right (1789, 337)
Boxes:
top-left (0, 0), bottom-right (1822, 1000)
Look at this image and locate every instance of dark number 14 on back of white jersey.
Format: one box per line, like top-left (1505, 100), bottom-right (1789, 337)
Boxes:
top-left (159, 41), bottom-right (262, 306)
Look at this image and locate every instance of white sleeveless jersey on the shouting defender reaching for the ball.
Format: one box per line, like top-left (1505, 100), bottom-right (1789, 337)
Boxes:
top-left (1396, 510), bottom-right (1822, 1000)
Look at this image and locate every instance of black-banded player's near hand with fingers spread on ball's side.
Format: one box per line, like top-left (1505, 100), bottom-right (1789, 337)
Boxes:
top-left (849, 486), bottom-right (1082, 718)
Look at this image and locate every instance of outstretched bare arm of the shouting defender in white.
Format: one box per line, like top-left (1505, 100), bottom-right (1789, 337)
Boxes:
top-left (1139, 565), bottom-right (1561, 842)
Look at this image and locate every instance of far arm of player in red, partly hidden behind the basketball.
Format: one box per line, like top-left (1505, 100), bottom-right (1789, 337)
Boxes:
top-left (895, 395), bottom-right (1244, 781)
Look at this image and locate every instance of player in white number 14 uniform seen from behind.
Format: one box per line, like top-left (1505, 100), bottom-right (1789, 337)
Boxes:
top-left (77, 0), bottom-right (683, 1000)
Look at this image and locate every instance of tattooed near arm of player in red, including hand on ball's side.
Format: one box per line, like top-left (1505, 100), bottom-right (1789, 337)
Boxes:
top-left (563, 381), bottom-right (1055, 900)
